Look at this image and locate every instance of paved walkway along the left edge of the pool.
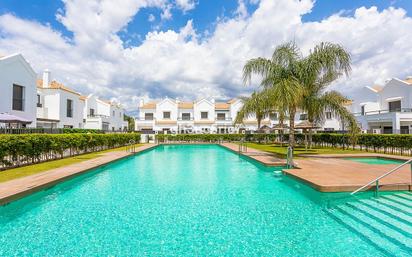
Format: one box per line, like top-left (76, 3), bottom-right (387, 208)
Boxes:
top-left (0, 144), bottom-right (156, 205)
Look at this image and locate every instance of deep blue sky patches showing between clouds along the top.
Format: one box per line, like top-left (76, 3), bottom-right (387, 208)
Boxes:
top-left (0, 0), bottom-right (412, 46)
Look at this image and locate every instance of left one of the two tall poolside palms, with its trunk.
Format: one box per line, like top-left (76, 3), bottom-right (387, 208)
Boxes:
top-left (243, 42), bottom-right (303, 147)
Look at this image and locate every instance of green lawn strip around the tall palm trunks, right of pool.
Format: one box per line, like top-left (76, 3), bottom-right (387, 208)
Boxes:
top-left (247, 143), bottom-right (362, 158)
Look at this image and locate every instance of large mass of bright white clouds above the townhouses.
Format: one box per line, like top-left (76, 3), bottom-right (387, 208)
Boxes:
top-left (0, 0), bottom-right (412, 110)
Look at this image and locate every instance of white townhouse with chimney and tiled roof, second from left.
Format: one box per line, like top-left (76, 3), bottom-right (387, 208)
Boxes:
top-left (36, 70), bottom-right (84, 128)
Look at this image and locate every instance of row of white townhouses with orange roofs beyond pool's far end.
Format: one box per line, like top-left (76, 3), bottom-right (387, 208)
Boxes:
top-left (135, 98), bottom-right (343, 134)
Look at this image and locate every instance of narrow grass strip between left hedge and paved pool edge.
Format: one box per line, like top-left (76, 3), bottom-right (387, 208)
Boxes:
top-left (0, 144), bottom-right (141, 183)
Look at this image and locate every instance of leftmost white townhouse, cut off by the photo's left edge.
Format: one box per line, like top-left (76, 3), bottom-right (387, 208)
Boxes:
top-left (0, 54), bottom-right (36, 127)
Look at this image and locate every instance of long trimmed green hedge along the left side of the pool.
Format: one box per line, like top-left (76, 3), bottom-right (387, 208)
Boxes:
top-left (0, 133), bottom-right (140, 167)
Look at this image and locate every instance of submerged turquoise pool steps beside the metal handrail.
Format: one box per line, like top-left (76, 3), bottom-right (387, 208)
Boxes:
top-left (327, 192), bottom-right (412, 256)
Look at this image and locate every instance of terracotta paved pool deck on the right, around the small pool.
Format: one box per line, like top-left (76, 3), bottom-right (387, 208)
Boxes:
top-left (221, 143), bottom-right (412, 192)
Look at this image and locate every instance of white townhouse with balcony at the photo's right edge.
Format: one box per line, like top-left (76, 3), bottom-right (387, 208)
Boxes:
top-left (352, 77), bottom-right (412, 134)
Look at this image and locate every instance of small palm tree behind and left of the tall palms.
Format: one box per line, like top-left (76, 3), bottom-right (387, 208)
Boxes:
top-left (235, 92), bottom-right (270, 129)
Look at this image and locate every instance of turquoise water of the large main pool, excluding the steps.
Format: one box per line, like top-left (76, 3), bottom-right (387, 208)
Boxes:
top-left (0, 145), bottom-right (392, 256)
